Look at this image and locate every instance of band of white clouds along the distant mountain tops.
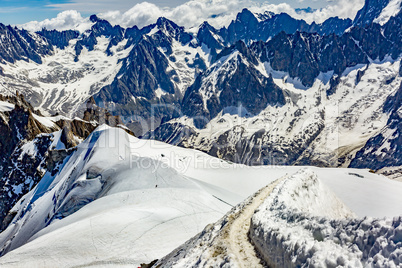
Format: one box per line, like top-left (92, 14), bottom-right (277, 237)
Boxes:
top-left (19, 0), bottom-right (364, 30)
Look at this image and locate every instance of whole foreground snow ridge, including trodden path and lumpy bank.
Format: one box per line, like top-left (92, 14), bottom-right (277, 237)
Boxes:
top-left (155, 168), bottom-right (402, 268)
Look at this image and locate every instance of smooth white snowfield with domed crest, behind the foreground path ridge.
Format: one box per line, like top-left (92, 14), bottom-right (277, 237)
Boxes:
top-left (0, 126), bottom-right (402, 267)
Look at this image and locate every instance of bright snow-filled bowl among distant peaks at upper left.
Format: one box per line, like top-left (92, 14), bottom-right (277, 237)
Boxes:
top-left (0, 37), bottom-right (132, 117)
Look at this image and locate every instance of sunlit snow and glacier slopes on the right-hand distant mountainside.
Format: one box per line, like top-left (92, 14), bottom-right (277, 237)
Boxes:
top-left (170, 56), bottom-right (402, 167)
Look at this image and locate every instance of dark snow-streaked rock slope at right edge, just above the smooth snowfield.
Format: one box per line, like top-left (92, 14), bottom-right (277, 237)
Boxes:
top-left (350, 84), bottom-right (402, 170)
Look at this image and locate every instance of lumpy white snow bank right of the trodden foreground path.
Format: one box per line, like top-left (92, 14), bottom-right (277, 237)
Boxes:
top-left (249, 169), bottom-right (402, 267)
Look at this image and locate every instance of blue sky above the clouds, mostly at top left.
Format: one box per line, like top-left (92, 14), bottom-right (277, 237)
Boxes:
top-left (0, 0), bottom-right (333, 24)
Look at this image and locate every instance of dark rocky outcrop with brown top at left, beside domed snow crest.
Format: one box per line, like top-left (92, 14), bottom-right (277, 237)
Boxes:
top-left (0, 94), bottom-right (109, 230)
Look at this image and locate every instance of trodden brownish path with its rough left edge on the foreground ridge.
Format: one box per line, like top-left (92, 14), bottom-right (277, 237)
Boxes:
top-left (155, 178), bottom-right (283, 268)
